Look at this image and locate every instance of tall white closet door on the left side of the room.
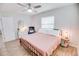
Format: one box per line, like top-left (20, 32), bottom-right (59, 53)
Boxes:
top-left (2, 17), bottom-right (15, 42)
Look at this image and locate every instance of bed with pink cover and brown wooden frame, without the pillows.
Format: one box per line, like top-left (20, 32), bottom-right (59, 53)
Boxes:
top-left (20, 32), bottom-right (61, 56)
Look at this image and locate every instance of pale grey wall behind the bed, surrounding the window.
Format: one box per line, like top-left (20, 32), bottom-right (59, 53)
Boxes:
top-left (32, 4), bottom-right (79, 44)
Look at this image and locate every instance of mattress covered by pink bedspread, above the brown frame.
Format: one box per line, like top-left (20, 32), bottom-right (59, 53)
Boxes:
top-left (21, 33), bottom-right (61, 55)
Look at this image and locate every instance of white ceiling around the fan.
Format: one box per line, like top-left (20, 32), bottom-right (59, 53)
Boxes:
top-left (0, 3), bottom-right (72, 15)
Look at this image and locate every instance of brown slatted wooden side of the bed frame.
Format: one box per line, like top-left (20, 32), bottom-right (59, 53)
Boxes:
top-left (19, 38), bottom-right (47, 56)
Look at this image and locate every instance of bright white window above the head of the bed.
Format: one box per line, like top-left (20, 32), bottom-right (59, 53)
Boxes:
top-left (41, 16), bottom-right (54, 29)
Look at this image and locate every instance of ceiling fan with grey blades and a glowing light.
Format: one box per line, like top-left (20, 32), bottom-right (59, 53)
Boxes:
top-left (17, 3), bottom-right (42, 13)
